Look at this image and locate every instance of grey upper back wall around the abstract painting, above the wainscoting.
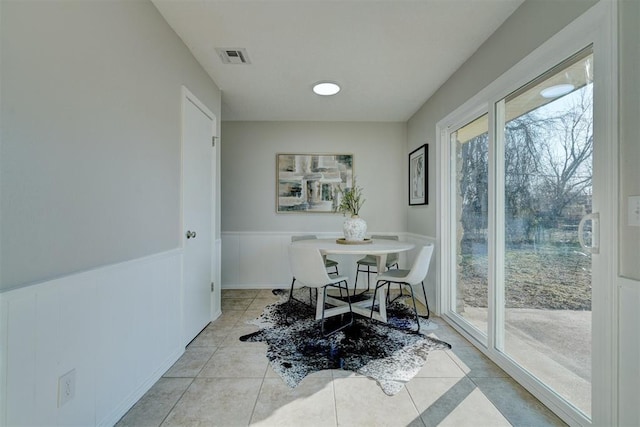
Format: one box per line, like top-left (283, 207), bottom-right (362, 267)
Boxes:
top-left (221, 122), bottom-right (407, 234)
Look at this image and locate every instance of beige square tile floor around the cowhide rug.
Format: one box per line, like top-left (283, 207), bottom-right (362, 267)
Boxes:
top-left (117, 290), bottom-right (565, 427)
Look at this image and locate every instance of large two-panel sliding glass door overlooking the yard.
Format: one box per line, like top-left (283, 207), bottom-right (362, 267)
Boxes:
top-left (439, 25), bottom-right (615, 423)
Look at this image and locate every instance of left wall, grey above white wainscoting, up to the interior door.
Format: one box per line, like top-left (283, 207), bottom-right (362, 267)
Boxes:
top-left (0, 0), bottom-right (221, 425)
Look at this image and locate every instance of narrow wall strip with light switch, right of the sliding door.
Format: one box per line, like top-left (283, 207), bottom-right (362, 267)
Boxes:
top-left (618, 0), bottom-right (640, 426)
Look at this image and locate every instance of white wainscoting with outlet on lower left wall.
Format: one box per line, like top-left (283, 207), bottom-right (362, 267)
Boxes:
top-left (0, 250), bottom-right (184, 426)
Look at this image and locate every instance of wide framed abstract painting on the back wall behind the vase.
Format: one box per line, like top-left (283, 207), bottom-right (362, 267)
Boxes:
top-left (276, 153), bottom-right (354, 213)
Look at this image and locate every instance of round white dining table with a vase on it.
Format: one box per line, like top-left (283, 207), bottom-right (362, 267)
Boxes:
top-left (291, 238), bottom-right (415, 323)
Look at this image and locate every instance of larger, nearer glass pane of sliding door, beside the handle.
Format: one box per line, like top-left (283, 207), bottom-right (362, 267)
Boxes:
top-left (496, 50), bottom-right (593, 416)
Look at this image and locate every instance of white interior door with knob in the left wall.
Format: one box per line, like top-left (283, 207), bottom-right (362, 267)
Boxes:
top-left (182, 90), bottom-right (215, 345)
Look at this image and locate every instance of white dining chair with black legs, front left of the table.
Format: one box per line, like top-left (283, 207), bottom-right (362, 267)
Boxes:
top-left (289, 245), bottom-right (353, 336)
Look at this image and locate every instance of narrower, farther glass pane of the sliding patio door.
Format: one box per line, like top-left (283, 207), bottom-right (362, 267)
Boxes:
top-left (450, 114), bottom-right (489, 339)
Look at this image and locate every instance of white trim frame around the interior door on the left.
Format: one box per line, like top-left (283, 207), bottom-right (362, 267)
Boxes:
top-left (178, 85), bottom-right (221, 342)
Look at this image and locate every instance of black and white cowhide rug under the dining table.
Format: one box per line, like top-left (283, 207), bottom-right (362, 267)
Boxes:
top-left (240, 290), bottom-right (451, 395)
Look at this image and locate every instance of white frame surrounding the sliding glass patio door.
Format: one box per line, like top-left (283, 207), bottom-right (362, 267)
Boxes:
top-left (436, 0), bottom-right (618, 425)
